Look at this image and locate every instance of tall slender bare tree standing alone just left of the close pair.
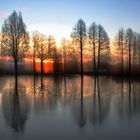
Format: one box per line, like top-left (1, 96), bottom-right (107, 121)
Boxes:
top-left (72, 19), bottom-right (86, 75)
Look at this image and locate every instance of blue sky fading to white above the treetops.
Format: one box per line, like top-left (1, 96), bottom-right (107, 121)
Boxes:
top-left (0, 0), bottom-right (140, 41)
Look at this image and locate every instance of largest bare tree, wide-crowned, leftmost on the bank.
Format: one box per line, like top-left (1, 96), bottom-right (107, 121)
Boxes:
top-left (1, 11), bottom-right (29, 81)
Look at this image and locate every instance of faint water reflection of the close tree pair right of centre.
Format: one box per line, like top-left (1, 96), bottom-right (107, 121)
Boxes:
top-left (89, 77), bottom-right (111, 125)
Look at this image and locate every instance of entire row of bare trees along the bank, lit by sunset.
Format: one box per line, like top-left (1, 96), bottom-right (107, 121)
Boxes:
top-left (0, 11), bottom-right (140, 77)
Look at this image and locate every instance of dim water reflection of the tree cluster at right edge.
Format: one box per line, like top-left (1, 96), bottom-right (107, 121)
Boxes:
top-left (116, 78), bottom-right (140, 121)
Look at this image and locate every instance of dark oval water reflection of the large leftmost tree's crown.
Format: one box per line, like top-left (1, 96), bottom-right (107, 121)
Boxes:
top-left (2, 78), bottom-right (30, 132)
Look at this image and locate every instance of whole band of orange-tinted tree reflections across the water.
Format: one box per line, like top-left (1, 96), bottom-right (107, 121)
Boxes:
top-left (1, 76), bottom-right (140, 136)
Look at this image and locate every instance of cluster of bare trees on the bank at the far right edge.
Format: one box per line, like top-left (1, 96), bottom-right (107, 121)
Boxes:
top-left (115, 28), bottom-right (140, 74)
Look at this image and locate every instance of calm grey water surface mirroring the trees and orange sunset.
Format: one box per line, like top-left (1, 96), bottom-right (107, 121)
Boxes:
top-left (0, 76), bottom-right (140, 140)
